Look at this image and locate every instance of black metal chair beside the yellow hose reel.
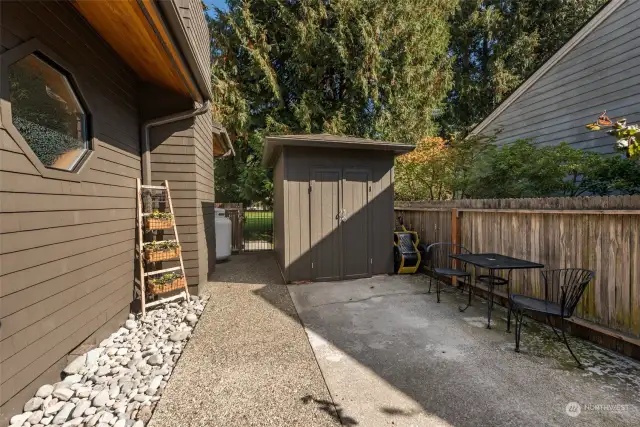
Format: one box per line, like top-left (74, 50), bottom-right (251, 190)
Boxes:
top-left (424, 242), bottom-right (471, 307)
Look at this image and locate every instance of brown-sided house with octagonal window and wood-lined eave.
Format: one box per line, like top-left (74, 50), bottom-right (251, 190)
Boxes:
top-left (0, 0), bottom-right (232, 423)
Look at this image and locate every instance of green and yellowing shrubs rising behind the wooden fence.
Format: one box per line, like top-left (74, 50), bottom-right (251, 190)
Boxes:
top-left (396, 139), bottom-right (640, 200)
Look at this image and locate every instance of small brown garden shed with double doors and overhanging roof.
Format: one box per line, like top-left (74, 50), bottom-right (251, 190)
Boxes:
top-left (263, 134), bottom-right (414, 283)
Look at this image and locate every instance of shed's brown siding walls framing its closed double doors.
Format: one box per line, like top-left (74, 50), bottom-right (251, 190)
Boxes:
top-left (283, 147), bottom-right (394, 281)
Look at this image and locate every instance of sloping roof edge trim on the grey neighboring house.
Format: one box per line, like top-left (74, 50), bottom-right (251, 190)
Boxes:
top-left (470, 0), bottom-right (625, 135)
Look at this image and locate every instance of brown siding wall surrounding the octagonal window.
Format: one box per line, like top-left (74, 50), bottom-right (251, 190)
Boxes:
top-left (0, 1), bottom-right (140, 422)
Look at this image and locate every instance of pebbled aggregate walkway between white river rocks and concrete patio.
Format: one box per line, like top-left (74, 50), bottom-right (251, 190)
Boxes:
top-left (149, 253), bottom-right (340, 427)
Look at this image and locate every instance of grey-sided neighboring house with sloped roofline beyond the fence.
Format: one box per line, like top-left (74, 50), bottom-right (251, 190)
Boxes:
top-left (472, 0), bottom-right (640, 154)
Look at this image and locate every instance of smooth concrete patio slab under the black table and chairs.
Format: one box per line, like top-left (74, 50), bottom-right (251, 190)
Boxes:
top-left (289, 276), bottom-right (640, 427)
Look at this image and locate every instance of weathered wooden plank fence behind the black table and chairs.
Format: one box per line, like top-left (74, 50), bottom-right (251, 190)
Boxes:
top-left (396, 196), bottom-right (640, 343)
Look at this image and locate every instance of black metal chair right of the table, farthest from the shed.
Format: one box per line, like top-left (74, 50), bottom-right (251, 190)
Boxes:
top-left (509, 268), bottom-right (595, 368)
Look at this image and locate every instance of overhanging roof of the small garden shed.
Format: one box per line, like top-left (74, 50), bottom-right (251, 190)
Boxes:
top-left (262, 133), bottom-right (415, 167)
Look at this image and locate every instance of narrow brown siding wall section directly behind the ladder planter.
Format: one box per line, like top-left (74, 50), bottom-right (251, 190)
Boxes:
top-left (143, 95), bottom-right (215, 293)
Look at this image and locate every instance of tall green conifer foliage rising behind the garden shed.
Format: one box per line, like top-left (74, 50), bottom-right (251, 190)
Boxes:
top-left (210, 0), bottom-right (455, 201)
